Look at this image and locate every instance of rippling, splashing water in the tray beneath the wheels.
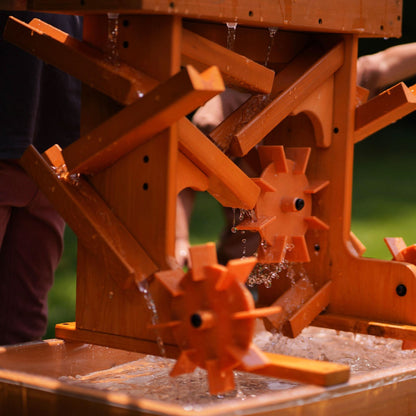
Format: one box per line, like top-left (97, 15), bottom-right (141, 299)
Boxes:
top-left (60, 324), bottom-right (416, 406)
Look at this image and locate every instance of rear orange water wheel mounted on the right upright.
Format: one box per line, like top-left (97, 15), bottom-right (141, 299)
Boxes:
top-left (237, 146), bottom-right (329, 263)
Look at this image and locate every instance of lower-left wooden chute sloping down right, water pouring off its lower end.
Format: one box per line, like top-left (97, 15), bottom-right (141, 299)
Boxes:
top-left (20, 146), bottom-right (158, 288)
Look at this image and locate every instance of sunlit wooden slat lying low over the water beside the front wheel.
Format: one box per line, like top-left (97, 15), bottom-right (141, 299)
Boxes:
top-left (252, 353), bottom-right (350, 386)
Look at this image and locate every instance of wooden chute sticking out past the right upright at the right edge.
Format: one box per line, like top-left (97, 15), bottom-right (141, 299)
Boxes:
top-left (354, 82), bottom-right (416, 143)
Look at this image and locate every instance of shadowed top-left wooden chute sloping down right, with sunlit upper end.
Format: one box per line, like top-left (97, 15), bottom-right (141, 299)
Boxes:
top-left (3, 17), bottom-right (158, 105)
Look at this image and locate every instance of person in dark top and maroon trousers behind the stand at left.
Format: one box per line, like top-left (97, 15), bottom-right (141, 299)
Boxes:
top-left (0, 10), bottom-right (82, 345)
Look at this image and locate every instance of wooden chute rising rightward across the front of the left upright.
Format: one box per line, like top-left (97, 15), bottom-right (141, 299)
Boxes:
top-left (63, 66), bottom-right (224, 174)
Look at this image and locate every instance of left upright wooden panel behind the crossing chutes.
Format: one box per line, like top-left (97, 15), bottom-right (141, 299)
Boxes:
top-left (76, 16), bottom-right (181, 344)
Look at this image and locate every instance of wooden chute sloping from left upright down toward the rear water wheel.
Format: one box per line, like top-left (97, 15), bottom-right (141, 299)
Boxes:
top-left (178, 118), bottom-right (260, 209)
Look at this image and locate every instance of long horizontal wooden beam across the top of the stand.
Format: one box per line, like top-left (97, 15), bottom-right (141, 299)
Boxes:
top-left (13, 0), bottom-right (402, 37)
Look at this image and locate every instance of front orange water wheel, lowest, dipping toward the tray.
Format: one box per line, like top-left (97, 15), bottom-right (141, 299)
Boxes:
top-left (155, 243), bottom-right (281, 394)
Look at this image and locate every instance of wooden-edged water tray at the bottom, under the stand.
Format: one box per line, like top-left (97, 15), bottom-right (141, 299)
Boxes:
top-left (0, 330), bottom-right (416, 416)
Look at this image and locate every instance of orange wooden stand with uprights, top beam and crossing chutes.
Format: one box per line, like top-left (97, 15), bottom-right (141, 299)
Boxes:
top-left (5, 0), bottom-right (416, 410)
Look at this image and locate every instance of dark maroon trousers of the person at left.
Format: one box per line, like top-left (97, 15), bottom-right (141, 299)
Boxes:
top-left (0, 161), bottom-right (64, 345)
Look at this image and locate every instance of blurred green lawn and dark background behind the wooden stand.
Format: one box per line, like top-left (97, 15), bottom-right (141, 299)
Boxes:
top-left (45, 0), bottom-right (416, 338)
